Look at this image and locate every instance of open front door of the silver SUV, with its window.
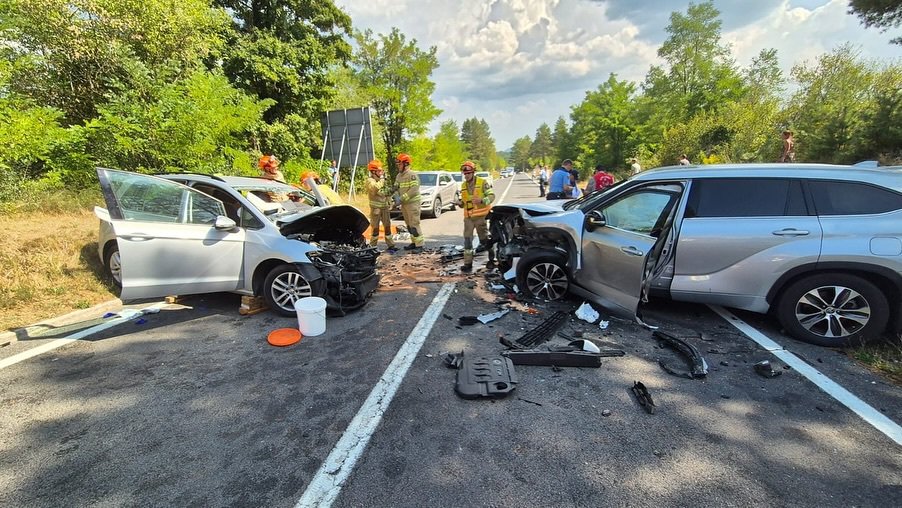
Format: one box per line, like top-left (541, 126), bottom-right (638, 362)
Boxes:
top-left (576, 183), bottom-right (683, 322)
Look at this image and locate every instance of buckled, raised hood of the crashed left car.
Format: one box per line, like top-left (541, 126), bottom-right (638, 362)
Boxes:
top-left (276, 205), bottom-right (370, 243)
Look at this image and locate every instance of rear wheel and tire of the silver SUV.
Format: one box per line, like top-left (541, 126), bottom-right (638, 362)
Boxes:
top-left (777, 273), bottom-right (889, 347)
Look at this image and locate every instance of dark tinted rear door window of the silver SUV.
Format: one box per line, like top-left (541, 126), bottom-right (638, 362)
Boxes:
top-left (686, 178), bottom-right (808, 218)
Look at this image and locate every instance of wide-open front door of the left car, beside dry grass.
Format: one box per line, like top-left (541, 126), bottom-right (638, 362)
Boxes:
top-left (97, 168), bottom-right (244, 300)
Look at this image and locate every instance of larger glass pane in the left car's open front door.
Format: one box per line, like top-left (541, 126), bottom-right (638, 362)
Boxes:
top-left (107, 171), bottom-right (193, 222)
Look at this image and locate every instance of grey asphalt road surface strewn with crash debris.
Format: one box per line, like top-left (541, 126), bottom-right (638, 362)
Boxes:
top-left (0, 175), bottom-right (902, 507)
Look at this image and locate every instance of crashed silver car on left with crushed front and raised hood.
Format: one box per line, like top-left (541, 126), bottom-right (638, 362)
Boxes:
top-left (94, 168), bottom-right (379, 316)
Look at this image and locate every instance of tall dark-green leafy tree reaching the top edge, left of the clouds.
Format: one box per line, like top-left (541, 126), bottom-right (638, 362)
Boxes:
top-left (214, 0), bottom-right (351, 125)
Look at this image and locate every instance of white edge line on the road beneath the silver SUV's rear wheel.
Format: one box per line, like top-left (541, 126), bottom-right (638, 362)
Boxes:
top-left (708, 305), bottom-right (902, 445)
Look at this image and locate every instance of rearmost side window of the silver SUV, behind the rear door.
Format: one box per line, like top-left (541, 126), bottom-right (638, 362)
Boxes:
top-left (809, 181), bottom-right (902, 215)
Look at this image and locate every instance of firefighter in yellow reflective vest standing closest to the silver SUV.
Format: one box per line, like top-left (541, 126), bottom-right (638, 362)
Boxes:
top-left (460, 161), bottom-right (495, 272)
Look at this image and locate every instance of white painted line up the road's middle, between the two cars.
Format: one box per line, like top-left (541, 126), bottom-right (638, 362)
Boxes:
top-left (296, 283), bottom-right (454, 508)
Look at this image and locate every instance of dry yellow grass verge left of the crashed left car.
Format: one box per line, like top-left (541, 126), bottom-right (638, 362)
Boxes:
top-left (0, 210), bottom-right (116, 329)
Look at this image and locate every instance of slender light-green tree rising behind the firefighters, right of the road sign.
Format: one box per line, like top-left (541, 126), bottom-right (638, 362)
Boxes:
top-left (353, 28), bottom-right (441, 178)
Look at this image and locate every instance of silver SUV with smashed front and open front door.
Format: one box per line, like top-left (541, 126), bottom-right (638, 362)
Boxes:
top-left (490, 164), bottom-right (902, 346)
